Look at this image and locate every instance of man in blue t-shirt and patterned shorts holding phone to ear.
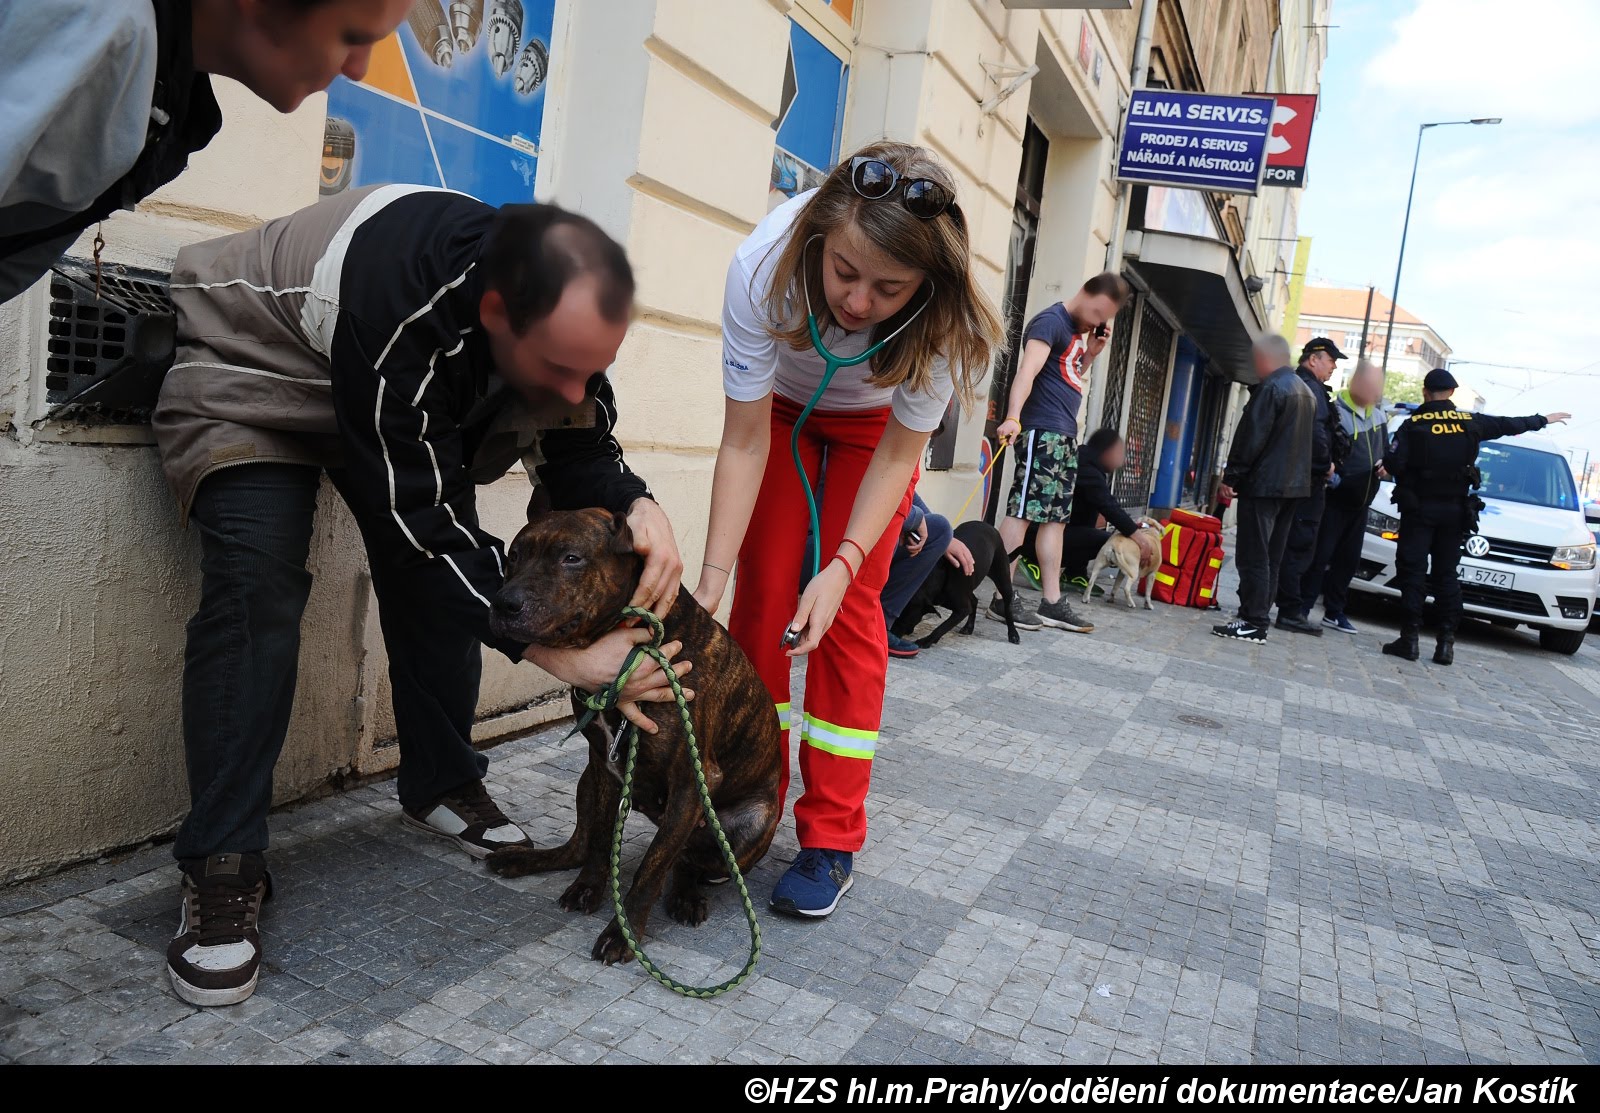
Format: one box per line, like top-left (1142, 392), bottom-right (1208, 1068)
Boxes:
top-left (989, 270), bottom-right (1128, 633)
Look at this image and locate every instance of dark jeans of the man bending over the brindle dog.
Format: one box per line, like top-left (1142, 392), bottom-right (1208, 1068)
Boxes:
top-left (173, 464), bottom-right (488, 860)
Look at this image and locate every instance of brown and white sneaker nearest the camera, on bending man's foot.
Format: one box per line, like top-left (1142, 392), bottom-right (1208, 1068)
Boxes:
top-left (166, 854), bottom-right (272, 1007)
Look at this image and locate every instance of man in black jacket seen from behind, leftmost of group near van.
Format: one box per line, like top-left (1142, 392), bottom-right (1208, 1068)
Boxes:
top-left (1211, 334), bottom-right (1317, 643)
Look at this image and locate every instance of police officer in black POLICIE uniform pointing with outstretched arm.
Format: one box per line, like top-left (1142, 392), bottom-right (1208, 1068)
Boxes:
top-left (1384, 368), bottom-right (1571, 665)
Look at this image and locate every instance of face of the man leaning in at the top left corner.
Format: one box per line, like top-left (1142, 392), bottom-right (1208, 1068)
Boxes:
top-left (226, 0), bottom-right (413, 112)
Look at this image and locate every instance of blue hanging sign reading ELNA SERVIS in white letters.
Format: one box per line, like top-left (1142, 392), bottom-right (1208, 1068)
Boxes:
top-left (1117, 90), bottom-right (1272, 193)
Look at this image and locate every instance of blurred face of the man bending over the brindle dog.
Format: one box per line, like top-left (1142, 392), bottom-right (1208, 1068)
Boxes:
top-left (478, 277), bottom-right (627, 406)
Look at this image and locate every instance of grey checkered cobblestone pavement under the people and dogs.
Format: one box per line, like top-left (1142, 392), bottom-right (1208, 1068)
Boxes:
top-left (0, 559), bottom-right (1600, 1063)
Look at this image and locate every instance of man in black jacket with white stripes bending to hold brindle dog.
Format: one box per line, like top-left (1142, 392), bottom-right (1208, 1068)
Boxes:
top-left (152, 186), bottom-right (683, 1006)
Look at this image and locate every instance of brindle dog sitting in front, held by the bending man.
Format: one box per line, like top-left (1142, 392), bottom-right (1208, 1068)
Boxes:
top-left (488, 510), bottom-right (782, 964)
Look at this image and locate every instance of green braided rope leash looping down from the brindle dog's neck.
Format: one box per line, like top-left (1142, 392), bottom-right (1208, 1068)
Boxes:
top-left (566, 606), bottom-right (762, 999)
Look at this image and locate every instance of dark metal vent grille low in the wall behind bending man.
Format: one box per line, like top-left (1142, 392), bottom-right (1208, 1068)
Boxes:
top-left (45, 259), bottom-right (176, 422)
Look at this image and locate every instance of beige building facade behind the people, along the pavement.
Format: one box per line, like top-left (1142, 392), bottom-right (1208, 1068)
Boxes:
top-left (0, 0), bottom-right (1328, 881)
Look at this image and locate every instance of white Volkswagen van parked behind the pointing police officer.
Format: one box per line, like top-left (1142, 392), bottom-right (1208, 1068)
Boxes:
top-left (1350, 416), bottom-right (1600, 654)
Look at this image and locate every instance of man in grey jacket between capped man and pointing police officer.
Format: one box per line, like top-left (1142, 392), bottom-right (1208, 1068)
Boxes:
top-left (1301, 360), bottom-right (1389, 633)
